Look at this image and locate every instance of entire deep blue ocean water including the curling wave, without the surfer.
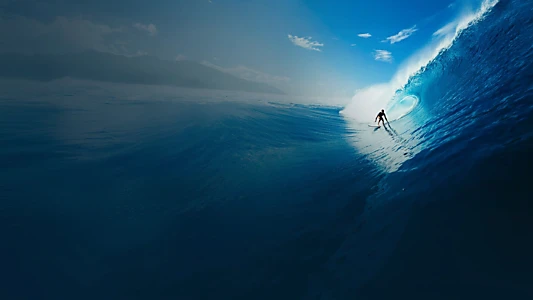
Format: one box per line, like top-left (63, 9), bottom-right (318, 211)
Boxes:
top-left (0, 0), bottom-right (533, 300)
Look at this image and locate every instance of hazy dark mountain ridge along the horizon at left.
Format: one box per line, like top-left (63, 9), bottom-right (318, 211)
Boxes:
top-left (0, 51), bottom-right (285, 95)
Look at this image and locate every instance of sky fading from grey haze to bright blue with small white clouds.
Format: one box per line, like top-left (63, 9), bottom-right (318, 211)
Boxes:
top-left (0, 0), bottom-right (482, 96)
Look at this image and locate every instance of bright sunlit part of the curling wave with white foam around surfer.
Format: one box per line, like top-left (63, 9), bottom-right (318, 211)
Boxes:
top-left (341, 0), bottom-right (533, 171)
